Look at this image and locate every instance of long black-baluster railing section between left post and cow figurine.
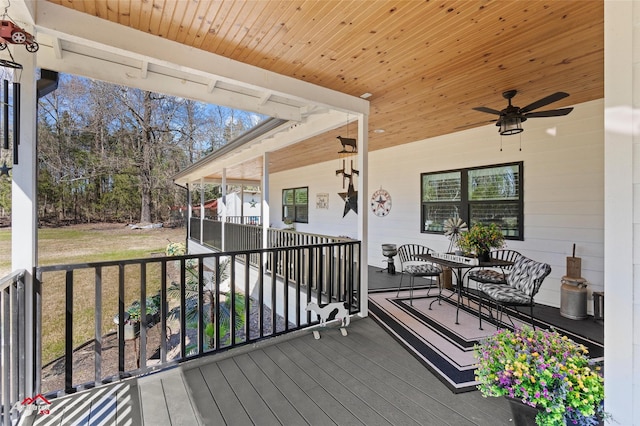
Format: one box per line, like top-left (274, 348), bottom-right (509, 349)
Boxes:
top-left (36, 240), bottom-right (362, 396)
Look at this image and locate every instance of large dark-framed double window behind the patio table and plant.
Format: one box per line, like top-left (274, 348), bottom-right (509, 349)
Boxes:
top-left (420, 162), bottom-right (524, 240)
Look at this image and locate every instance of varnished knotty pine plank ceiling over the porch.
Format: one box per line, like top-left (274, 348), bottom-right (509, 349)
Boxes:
top-left (49, 0), bottom-right (604, 181)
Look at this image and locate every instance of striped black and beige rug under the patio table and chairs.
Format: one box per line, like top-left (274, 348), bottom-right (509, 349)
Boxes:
top-left (369, 289), bottom-right (604, 393)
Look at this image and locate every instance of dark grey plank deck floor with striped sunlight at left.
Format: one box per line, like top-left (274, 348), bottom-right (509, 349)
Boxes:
top-left (24, 271), bottom-right (601, 426)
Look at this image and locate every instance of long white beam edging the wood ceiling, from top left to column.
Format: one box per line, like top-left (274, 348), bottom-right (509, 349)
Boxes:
top-left (35, 1), bottom-right (369, 113)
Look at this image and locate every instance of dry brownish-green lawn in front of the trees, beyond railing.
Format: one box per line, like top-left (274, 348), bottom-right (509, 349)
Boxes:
top-left (0, 224), bottom-right (186, 364)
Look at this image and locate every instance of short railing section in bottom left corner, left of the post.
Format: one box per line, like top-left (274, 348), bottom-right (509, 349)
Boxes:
top-left (0, 270), bottom-right (38, 425)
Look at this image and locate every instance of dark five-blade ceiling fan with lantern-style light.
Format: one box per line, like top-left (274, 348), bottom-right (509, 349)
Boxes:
top-left (473, 90), bottom-right (573, 136)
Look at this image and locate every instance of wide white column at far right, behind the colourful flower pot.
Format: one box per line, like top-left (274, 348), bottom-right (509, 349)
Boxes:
top-left (604, 0), bottom-right (640, 425)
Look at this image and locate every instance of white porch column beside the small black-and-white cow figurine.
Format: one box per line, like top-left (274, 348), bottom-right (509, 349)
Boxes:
top-left (358, 114), bottom-right (370, 317)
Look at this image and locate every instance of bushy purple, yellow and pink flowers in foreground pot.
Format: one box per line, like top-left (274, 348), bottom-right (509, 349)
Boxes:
top-left (474, 326), bottom-right (606, 425)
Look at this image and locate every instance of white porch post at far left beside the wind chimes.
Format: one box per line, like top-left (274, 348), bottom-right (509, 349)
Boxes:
top-left (9, 46), bottom-right (39, 396)
